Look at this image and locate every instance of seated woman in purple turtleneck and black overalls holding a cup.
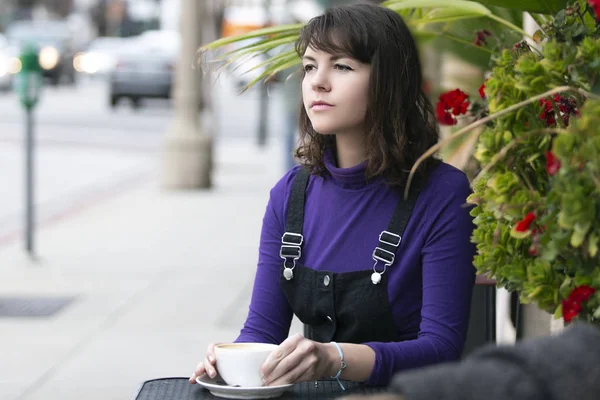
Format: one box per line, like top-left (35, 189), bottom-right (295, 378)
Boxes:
top-left (190, 0), bottom-right (475, 385)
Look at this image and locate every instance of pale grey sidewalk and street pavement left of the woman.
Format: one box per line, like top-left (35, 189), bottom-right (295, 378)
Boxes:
top-left (0, 73), bottom-right (300, 400)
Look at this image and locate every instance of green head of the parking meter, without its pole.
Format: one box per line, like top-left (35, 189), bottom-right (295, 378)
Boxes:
top-left (16, 45), bottom-right (42, 110)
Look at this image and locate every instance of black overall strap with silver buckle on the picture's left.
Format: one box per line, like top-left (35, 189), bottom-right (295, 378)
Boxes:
top-left (279, 167), bottom-right (310, 268)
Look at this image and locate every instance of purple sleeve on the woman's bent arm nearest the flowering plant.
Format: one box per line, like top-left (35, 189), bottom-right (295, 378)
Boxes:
top-left (366, 171), bottom-right (475, 385)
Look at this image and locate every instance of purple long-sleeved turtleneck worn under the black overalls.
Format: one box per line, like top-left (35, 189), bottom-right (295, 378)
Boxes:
top-left (236, 154), bottom-right (475, 385)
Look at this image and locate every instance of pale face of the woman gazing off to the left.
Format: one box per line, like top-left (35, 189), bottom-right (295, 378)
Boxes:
top-left (302, 47), bottom-right (371, 136)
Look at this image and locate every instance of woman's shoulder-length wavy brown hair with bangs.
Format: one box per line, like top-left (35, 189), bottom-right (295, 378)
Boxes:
top-left (296, 3), bottom-right (439, 187)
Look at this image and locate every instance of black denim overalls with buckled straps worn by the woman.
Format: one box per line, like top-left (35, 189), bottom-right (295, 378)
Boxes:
top-left (280, 168), bottom-right (418, 343)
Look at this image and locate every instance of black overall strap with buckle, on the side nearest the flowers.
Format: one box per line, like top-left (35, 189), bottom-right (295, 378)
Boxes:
top-left (373, 189), bottom-right (419, 267)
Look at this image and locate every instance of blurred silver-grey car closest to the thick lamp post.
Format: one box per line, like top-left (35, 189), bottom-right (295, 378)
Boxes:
top-left (109, 31), bottom-right (180, 108)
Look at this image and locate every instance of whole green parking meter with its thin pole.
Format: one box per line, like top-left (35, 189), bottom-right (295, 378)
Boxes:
top-left (16, 46), bottom-right (42, 256)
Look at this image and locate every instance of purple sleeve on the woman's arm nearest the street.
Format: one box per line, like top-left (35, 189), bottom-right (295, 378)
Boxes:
top-left (236, 169), bottom-right (296, 344)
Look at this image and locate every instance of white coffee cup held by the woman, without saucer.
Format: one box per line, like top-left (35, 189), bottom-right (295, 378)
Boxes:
top-left (214, 343), bottom-right (278, 387)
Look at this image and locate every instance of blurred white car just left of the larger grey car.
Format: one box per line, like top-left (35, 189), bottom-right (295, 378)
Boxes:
top-left (73, 37), bottom-right (129, 77)
